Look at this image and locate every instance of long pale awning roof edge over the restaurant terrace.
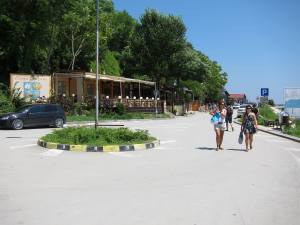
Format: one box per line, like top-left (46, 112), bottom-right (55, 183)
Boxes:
top-left (54, 72), bottom-right (155, 86)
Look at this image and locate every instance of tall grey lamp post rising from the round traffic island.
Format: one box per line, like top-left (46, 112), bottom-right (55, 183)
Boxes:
top-left (95, 0), bottom-right (99, 129)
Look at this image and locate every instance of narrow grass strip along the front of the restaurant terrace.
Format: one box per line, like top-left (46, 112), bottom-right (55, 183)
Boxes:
top-left (67, 113), bottom-right (170, 122)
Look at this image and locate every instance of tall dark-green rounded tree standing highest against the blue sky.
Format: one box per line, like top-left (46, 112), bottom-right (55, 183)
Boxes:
top-left (132, 10), bottom-right (186, 89)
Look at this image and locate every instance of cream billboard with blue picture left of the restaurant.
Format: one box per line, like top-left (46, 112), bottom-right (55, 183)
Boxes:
top-left (10, 74), bottom-right (51, 99)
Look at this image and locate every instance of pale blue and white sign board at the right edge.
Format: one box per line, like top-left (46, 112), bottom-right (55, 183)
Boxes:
top-left (284, 87), bottom-right (300, 118)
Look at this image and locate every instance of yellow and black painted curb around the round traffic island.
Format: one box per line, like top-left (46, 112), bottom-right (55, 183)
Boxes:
top-left (37, 139), bottom-right (160, 152)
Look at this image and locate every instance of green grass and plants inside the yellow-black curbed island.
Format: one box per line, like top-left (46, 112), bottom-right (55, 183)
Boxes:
top-left (41, 127), bottom-right (156, 146)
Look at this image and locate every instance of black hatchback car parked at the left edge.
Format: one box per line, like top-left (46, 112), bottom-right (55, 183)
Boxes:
top-left (0, 104), bottom-right (66, 130)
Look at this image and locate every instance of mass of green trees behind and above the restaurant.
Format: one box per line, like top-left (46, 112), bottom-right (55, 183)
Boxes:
top-left (0, 0), bottom-right (227, 100)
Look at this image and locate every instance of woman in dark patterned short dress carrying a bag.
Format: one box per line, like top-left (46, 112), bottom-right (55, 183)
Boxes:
top-left (241, 105), bottom-right (257, 152)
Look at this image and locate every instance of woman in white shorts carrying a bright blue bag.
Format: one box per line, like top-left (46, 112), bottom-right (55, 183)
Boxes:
top-left (210, 101), bottom-right (226, 151)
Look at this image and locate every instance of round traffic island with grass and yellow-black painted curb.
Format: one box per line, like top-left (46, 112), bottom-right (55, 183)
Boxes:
top-left (38, 127), bottom-right (160, 152)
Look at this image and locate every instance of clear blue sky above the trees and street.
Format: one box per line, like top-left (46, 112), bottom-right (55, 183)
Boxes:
top-left (113, 0), bottom-right (300, 103)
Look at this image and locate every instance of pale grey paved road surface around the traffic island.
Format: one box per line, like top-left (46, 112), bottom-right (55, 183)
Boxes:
top-left (0, 113), bottom-right (300, 225)
